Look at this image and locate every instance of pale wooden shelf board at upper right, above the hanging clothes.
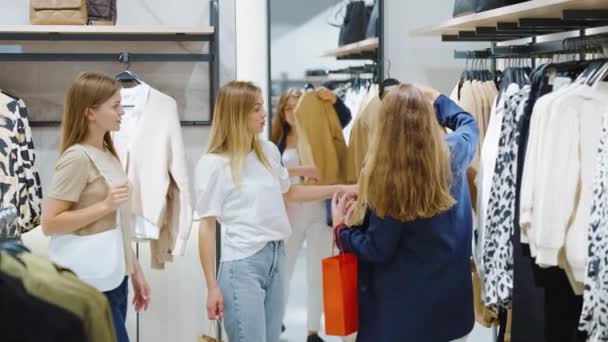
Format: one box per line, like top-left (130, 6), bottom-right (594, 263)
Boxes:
top-left (411, 0), bottom-right (608, 36)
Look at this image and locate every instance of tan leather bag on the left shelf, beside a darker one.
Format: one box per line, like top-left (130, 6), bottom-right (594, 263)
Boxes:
top-left (30, 0), bottom-right (88, 25)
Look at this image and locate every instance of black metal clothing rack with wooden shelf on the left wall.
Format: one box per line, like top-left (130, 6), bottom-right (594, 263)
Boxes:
top-left (0, 0), bottom-right (220, 127)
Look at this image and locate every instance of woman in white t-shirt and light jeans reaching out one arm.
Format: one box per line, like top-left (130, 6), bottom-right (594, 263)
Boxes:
top-left (195, 81), bottom-right (355, 342)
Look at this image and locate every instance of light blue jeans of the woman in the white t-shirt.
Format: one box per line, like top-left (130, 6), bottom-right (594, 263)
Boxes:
top-left (219, 241), bottom-right (285, 342)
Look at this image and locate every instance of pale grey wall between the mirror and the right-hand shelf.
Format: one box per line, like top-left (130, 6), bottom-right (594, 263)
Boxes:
top-left (384, 0), bottom-right (489, 93)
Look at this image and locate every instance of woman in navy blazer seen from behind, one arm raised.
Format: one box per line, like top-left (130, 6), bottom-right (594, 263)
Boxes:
top-left (333, 84), bottom-right (479, 342)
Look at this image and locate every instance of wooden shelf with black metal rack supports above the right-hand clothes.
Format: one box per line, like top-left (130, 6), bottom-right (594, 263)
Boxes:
top-left (412, 0), bottom-right (608, 340)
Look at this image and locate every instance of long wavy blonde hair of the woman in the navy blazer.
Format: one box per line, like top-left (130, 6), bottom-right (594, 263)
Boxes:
top-left (353, 84), bottom-right (456, 223)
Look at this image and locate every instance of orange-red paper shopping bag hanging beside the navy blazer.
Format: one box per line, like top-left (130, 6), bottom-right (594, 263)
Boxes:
top-left (323, 226), bottom-right (359, 336)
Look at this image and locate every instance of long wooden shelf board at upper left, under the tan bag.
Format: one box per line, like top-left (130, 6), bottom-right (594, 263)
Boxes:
top-left (0, 25), bottom-right (214, 41)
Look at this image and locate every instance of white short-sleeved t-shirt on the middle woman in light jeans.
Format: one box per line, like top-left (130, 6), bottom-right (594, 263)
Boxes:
top-left (195, 141), bottom-right (291, 261)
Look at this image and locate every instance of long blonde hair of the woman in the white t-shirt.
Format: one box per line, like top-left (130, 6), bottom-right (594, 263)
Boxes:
top-left (207, 81), bottom-right (270, 185)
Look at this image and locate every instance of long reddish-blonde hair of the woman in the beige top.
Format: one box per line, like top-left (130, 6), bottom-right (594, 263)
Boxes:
top-left (61, 72), bottom-right (121, 158)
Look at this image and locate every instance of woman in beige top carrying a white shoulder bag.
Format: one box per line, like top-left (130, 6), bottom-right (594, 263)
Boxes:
top-left (42, 73), bottom-right (150, 342)
